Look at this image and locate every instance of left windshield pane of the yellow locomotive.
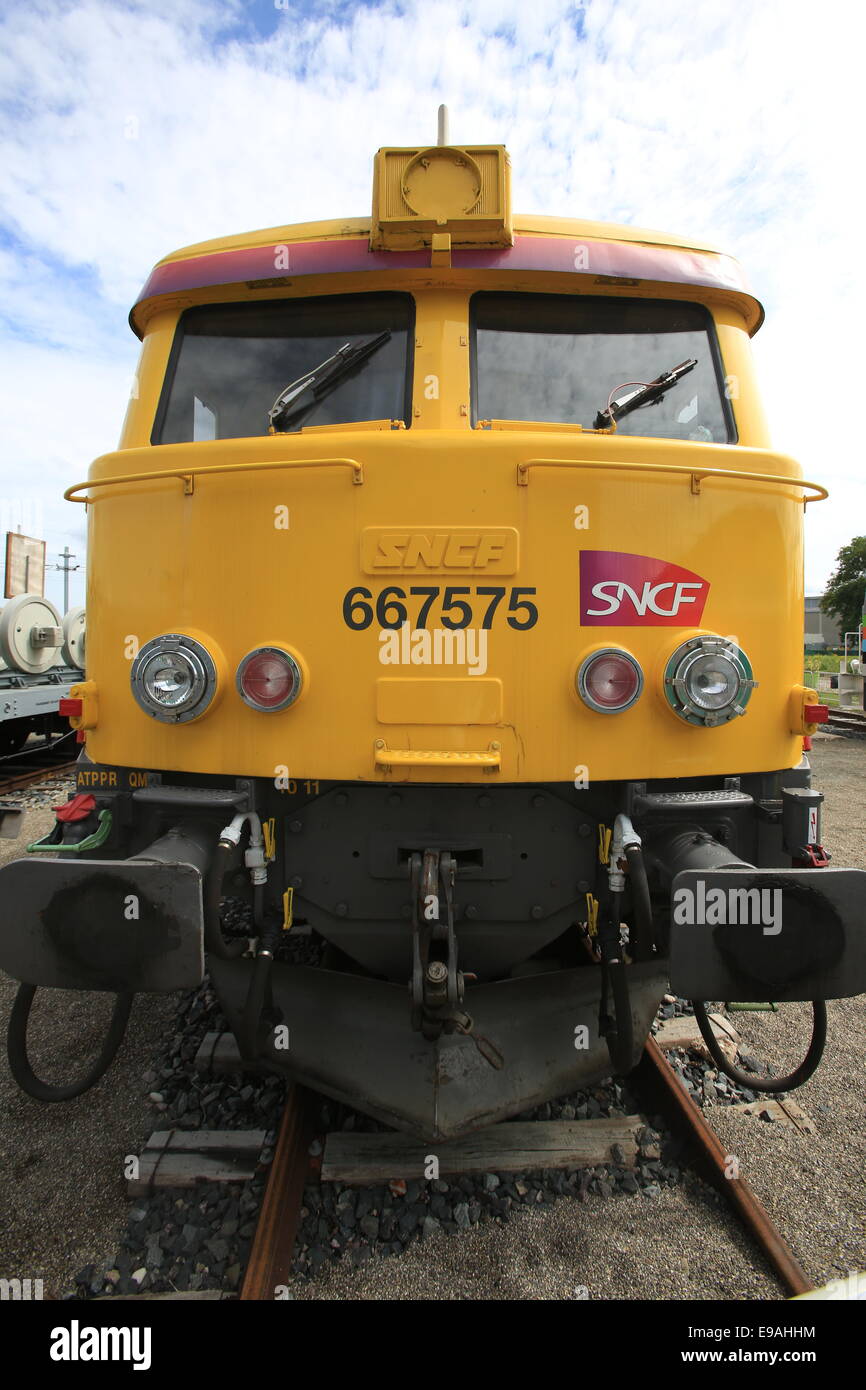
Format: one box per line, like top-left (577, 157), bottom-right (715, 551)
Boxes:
top-left (153, 295), bottom-right (414, 443)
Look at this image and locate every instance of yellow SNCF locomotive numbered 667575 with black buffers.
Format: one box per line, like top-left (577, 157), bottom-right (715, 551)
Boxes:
top-left (0, 125), bottom-right (866, 1138)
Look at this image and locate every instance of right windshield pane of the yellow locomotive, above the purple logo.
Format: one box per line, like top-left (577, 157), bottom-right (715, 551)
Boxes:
top-left (471, 293), bottom-right (735, 443)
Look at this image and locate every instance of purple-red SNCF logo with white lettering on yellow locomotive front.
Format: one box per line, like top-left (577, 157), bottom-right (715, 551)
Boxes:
top-left (580, 550), bottom-right (710, 627)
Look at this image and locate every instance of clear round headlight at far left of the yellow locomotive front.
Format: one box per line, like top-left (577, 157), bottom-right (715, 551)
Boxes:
top-left (129, 632), bottom-right (217, 724)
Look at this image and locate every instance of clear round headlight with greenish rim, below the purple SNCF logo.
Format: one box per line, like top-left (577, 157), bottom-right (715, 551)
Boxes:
top-left (664, 637), bottom-right (758, 728)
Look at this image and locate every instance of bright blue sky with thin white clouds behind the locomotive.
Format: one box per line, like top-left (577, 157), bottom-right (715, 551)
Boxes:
top-left (0, 0), bottom-right (866, 606)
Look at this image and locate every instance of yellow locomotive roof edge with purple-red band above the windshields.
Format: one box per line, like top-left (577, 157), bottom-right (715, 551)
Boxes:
top-left (129, 215), bottom-right (763, 338)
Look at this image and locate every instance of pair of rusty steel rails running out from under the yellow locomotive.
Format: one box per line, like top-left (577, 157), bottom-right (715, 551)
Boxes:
top-left (239, 1038), bottom-right (815, 1301)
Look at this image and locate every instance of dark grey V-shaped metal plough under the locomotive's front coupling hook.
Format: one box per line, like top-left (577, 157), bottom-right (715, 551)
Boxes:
top-left (210, 959), bottom-right (667, 1138)
